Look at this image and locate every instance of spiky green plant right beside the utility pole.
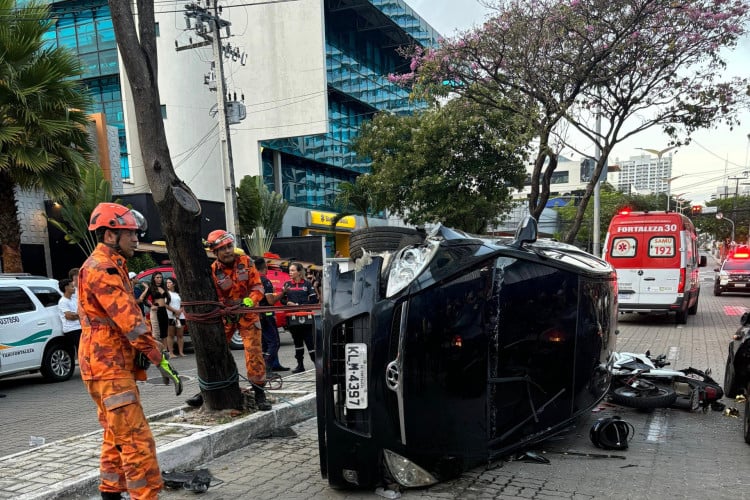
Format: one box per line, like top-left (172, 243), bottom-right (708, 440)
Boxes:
top-left (237, 175), bottom-right (289, 256)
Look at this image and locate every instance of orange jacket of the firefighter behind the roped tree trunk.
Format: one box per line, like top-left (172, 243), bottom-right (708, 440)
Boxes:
top-left (211, 255), bottom-right (265, 337)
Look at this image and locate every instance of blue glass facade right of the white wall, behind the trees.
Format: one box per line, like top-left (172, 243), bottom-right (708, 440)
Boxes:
top-left (262, 0), bottom-right (439, 210)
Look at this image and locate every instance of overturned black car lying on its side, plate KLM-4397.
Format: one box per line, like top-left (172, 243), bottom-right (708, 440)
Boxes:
top-left (317, 218), bottom-right (617, 488)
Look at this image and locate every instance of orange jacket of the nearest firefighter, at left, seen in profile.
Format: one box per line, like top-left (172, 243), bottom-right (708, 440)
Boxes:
top-left (78, 243), bottom-right (162, 380)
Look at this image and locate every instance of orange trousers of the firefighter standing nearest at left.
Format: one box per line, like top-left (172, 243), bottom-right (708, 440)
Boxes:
top-left (84, 379), bottom-right (163, 500)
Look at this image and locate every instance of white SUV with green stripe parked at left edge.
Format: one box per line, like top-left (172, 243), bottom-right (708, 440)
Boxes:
top-left (0, 274), bottom-right (76, 382)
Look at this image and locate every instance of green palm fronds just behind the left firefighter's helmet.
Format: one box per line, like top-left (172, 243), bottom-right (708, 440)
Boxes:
top-left (47, 165), bottom-right (114, 255)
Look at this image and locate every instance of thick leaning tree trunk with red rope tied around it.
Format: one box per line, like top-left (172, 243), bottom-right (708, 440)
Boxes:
top-left (109, 0), bottom-right (243, 410)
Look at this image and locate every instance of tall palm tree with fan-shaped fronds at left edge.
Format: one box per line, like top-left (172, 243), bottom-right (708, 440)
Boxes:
top-left (0, 0), bottom-right (91, 272)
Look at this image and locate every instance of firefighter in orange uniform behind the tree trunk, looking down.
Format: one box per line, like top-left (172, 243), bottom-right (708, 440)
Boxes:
top-left (207, 229), bottom-right (271, 411)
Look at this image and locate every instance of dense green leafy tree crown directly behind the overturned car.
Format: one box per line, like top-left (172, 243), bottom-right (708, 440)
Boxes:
top-left (353, 99), bottom-right (530, 233)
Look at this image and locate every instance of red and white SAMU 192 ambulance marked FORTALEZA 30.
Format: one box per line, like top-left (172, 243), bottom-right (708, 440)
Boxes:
top-left (602, 210), bottom-right (706, 324)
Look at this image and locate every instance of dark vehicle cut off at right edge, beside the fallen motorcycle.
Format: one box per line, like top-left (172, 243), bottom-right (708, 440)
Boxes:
top-left (724, 312), bottom-right (750, 444)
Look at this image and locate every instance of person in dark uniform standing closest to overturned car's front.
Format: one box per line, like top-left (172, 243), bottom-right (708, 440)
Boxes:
top-left (281, 262), bottom-right (318, 373)
